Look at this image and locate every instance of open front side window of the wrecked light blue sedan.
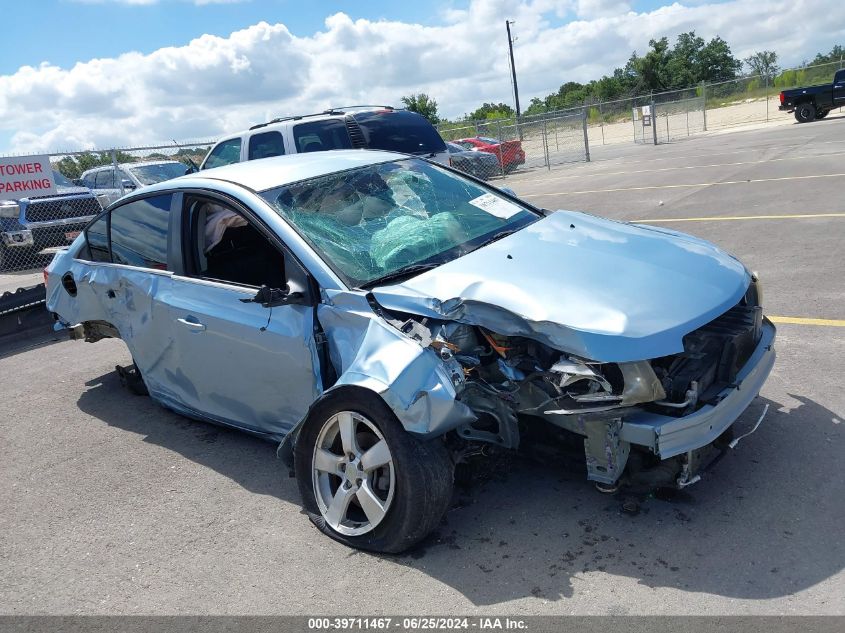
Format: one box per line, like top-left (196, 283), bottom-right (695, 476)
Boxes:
top-left (185, 197), bottom-right (286, 288)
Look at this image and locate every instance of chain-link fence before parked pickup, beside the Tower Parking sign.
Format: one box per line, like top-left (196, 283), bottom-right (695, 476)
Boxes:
top-left (0, 141), bottom-right (213, 273)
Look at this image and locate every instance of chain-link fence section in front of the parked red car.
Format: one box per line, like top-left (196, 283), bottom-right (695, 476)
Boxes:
top-left (438, 109), bottom-right (590, 179)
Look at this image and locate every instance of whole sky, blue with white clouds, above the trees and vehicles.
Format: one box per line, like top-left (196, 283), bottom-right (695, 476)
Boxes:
top-left (0, 0), bottom-right (845, 153)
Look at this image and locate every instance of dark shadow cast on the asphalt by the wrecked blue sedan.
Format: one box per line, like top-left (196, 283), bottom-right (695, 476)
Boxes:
top-left (79, 373), bottom-right (845, 613)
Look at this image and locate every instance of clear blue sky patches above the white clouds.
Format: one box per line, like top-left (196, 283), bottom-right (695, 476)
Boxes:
top-left (0, 0), bottom-right (722, 74)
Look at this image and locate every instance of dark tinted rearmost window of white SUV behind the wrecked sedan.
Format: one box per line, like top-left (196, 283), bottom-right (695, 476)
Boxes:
top-left (353, 110), bottom-right (446, 154)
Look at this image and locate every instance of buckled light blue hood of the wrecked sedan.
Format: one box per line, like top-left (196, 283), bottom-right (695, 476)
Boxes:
top-left (372, 211), bottom-right (751, 362)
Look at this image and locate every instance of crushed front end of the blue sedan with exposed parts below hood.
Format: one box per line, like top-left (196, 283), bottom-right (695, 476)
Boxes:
top-left (380, 282), bottom-right (775, 488)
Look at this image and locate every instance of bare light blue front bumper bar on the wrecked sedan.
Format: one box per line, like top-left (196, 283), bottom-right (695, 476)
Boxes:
top-left (619, 318), bottom-right (775, 459)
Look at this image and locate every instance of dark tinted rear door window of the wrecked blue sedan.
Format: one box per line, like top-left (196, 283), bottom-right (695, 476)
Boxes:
top-left (109, 194), bottom-right (172, 270)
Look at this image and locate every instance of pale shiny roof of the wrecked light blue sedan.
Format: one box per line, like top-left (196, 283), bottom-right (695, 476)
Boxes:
top-left (166, 149), bottom-right (414, 191)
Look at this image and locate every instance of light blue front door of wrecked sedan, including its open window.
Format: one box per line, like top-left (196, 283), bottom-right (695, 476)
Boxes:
top-left (164, 195), bottom-right (321, 437)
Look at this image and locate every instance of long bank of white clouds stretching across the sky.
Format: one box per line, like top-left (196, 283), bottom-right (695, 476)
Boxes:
top-left (0, 0), bottom-right (845, 152)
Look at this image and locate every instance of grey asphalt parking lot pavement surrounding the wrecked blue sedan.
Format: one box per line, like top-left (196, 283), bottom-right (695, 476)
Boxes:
top-left (0, 114), bottom-right (845, 615)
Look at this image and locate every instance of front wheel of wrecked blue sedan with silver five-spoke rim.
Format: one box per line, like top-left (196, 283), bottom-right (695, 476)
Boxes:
top-left (294, 393), bottom-right (454, 553)
